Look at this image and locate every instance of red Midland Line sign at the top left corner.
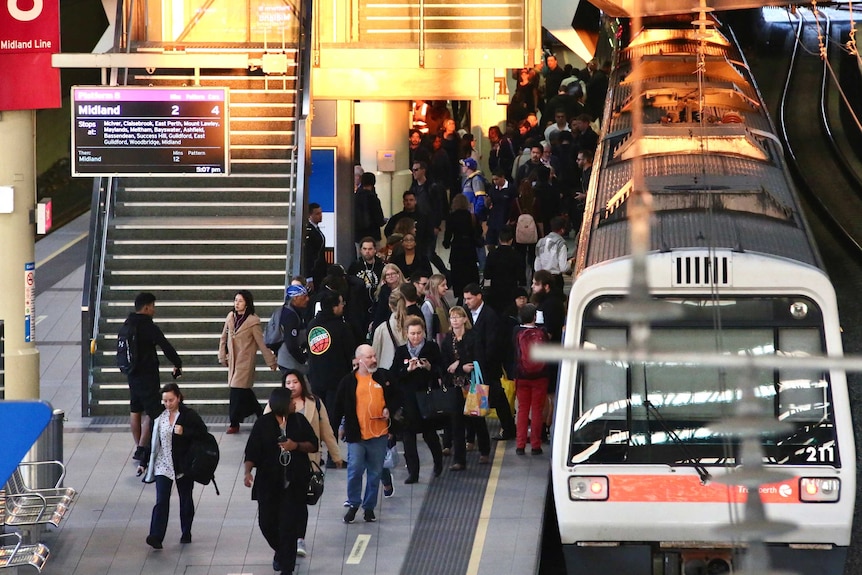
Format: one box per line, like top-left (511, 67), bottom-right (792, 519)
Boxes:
top-left (0, 0), bottom-right (60, 110)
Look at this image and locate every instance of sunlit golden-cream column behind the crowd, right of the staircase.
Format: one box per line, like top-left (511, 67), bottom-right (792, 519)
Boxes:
top-left (355, 101), bottom-right (413, 217)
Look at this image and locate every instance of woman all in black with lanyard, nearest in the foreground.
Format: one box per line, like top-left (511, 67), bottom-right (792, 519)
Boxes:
top-left (243, 388), bottom-right (320, 573)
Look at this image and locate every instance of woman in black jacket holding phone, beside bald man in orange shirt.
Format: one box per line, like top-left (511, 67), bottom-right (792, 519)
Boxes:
top-left (390, 316), bottom-right (443, 484)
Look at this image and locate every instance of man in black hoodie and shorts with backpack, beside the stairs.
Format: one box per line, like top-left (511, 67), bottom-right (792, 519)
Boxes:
top-left (123, 292), bottom-right (183, 465)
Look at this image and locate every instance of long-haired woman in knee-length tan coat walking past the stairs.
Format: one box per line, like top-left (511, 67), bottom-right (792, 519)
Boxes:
top-left (218, 290), bottom-right (278, 433)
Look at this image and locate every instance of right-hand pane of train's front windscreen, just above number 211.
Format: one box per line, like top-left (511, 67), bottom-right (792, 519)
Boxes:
top-left (778, 328), bottom-right (831, 423)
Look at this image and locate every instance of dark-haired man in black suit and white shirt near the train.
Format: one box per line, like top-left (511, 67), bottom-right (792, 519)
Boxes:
top-left (464, 283), bottom-right (515, 441)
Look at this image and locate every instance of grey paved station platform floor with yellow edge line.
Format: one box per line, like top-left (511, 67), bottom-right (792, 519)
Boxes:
top-left (28, 214), bottom-right (550, 575)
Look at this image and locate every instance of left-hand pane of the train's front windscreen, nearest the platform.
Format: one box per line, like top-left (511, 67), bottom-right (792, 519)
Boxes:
top-left (581, 328), bottom-right (628, 420)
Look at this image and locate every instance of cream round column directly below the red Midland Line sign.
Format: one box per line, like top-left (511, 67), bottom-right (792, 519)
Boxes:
top-left (0, 110), bottom-right (39, 399)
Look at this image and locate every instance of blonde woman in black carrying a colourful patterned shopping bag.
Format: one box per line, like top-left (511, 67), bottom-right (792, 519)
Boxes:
top-left (440, 306), bottom-right (491, 471)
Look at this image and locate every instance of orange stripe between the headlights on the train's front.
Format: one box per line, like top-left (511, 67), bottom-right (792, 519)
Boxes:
top-left (608, 475), bottom-right (800, 503)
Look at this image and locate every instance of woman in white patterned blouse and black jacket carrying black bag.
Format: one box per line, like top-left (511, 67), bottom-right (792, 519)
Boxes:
top-left (144, 383), bottom-right (207, 549)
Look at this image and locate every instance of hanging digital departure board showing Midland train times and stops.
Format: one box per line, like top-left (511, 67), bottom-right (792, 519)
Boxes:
top-left (72, 86), bottom-right (230, 176)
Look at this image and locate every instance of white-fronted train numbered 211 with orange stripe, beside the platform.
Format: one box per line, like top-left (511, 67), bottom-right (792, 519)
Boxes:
top-left (551, 14), bottom-right (856, 575)
